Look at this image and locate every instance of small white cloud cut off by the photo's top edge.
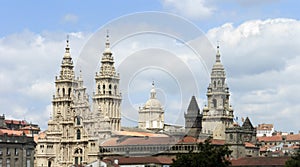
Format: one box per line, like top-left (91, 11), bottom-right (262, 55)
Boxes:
top-left (163, 0), bottom-right (216, 19)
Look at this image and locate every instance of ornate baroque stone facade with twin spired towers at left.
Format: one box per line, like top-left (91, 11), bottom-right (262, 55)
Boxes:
top-left (36, 36), bottom-right (121, 167)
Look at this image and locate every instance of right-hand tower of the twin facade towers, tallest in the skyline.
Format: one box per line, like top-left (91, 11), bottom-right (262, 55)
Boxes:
top-left (93, 34), bottom-right (122, 131)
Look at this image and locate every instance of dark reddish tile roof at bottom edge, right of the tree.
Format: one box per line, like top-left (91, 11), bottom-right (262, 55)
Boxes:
top-left (231, 157), bottom-right (289, 166)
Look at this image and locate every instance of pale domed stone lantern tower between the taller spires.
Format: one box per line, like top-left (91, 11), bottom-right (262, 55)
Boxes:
top-left (138, 82), bottom-right (164, 131)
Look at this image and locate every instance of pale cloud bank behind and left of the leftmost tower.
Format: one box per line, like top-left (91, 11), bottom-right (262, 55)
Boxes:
top-left (0, 31), bottom-right (88, 129)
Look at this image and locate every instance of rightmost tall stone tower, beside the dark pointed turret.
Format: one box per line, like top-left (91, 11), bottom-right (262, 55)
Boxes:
top-left (202, 46), bottom-right (233, 139)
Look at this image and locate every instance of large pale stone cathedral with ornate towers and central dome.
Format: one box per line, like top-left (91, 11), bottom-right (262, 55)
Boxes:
top-left (35, 35), bottom-right (254, 167)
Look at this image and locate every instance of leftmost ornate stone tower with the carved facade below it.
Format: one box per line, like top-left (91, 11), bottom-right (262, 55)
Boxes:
top-left (36, 40), bottom-right (97, 167)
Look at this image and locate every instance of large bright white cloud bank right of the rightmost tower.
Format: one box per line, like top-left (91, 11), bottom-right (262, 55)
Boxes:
top-left (207, 18), bottom-right (300, 131)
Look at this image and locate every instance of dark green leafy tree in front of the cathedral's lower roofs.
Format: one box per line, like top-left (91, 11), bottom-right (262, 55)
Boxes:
top-left (172, 138), bottom-right (232, 167)
